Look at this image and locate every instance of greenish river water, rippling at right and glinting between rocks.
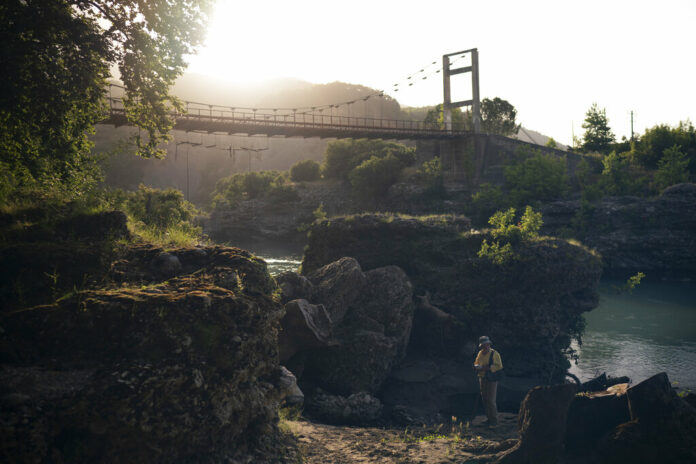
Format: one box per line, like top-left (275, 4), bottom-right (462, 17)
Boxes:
top-left (258, 249), bottom-right (696, 390)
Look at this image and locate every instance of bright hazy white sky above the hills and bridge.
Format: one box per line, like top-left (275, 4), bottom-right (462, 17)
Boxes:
top-left (189, 0), bottom-right (696, 143)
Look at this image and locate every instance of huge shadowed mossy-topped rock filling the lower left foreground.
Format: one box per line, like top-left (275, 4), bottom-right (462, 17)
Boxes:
top-left (0, 247), bottom-right (283, 463)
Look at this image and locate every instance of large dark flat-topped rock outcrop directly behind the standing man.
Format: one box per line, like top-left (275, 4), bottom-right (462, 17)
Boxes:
top-left (302, 214), bottom-right (601, 416)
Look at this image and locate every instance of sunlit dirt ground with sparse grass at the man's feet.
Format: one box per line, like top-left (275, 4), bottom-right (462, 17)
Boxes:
top-left (286, 414), bottom-right (518, 464)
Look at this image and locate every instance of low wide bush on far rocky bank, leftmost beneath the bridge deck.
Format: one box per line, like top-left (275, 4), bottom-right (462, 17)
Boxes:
top-left (213, 171), bottom-right (299, 207)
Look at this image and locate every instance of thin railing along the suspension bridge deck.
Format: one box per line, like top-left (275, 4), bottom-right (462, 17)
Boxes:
top-left (108, 97), bottom-right (452, 132)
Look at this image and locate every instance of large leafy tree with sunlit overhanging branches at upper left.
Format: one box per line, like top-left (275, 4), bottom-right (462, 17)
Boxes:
top-left (0, 0), bottom-right (211, 190)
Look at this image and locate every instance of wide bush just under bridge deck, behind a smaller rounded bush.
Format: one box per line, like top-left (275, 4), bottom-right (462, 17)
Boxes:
top-left (321, 139), bottom-right (416, 179)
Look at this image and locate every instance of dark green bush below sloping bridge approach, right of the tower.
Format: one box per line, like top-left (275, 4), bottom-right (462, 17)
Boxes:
top-left (504, 152), bottom-right (568, 206)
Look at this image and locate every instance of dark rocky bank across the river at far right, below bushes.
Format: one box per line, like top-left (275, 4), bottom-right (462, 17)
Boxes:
top-left (542, 184), bottom-right (696, 279)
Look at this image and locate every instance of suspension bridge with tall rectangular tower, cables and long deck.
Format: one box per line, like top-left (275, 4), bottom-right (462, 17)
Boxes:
top-left (101, 49), bottom-right (480, 140)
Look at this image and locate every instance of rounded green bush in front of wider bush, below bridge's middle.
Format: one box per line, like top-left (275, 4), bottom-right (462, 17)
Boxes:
top-left (349, 153), bottom-right (403, 198)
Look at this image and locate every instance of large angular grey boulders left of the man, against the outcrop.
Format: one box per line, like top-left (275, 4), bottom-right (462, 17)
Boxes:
top-left (278, 258), bottom-right (413, 397)
